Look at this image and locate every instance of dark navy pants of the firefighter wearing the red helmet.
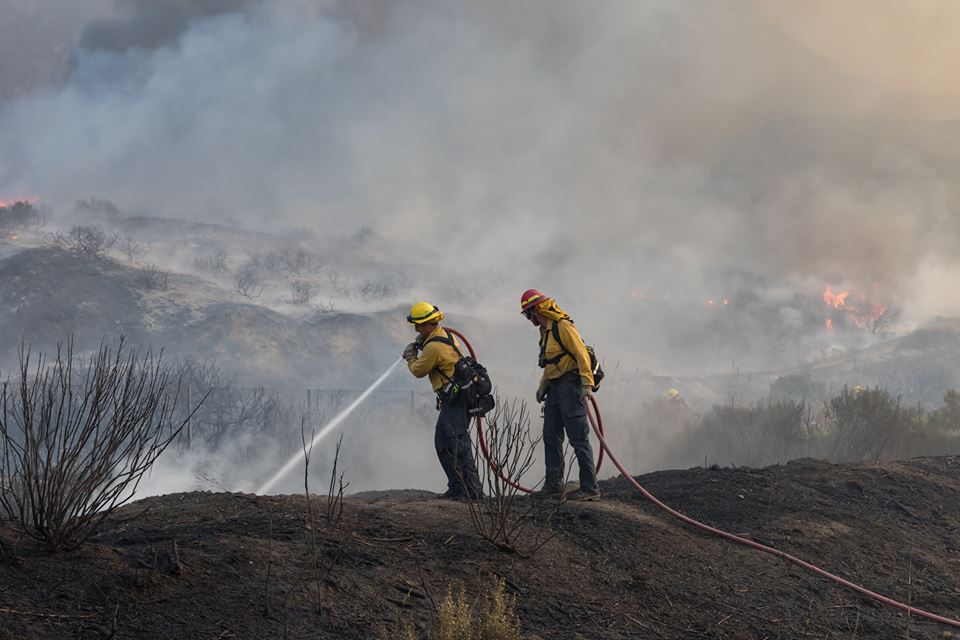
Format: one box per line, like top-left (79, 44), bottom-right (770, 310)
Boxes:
top-left (543, 372), bottom-right (597, 492)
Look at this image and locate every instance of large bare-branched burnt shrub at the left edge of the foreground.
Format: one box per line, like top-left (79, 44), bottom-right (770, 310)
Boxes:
top-left (0, 339), bottom-right (202, 552)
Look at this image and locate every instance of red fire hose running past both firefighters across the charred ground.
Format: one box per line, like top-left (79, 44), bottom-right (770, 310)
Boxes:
top-left (448, 329), bottom-right (960, 629)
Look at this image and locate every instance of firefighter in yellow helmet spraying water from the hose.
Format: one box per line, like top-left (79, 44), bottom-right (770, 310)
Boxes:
top-left (403, 302), bottom-right (483, 500)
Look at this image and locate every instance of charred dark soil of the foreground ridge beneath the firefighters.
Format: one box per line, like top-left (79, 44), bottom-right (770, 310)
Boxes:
top-left (0, 457), bottom-right (960, 640)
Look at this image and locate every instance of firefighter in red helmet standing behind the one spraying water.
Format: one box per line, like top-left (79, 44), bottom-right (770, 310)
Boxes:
top-left (520, 289), bottom-right (600, 501)
